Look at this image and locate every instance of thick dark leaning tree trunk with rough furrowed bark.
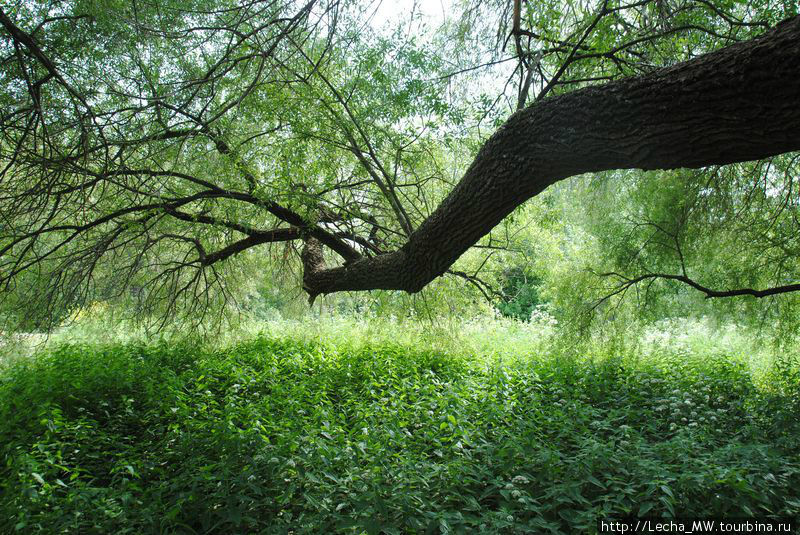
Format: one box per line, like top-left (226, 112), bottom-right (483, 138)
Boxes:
top-left (303, 17), bottom-right (800, 301)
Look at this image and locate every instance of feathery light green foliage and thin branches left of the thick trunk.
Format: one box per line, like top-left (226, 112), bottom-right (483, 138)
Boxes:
top-left (0, 0), bottom-right (468, 329)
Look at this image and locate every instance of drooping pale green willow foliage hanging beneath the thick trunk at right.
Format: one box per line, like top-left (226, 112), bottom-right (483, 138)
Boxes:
top-left (522, 154), bottom-right (800, 340)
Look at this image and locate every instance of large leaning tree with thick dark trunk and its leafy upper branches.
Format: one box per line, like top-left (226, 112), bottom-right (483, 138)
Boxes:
top-left (0, 1), bottom-right (800, 326)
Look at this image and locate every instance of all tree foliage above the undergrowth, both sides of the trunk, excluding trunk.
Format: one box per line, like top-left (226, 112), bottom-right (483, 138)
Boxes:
top-left (0, 0), bottom-right (800, 333)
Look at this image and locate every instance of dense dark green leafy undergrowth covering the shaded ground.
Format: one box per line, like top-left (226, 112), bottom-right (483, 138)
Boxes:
top-left (0, 337), bottom-right (800, 534)
